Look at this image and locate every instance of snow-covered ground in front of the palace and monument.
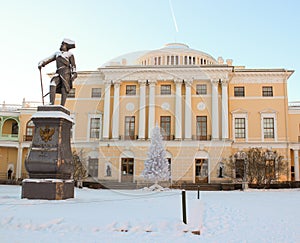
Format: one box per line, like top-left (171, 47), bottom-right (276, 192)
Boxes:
top-left (0, 185), bottom-right (300, 243)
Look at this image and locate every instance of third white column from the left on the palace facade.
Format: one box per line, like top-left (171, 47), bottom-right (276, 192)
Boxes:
top-left (139, 80), bottom-right (146, 140)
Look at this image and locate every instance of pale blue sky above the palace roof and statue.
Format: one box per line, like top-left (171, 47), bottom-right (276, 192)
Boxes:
top-left (0, 0), bottom-right (300, 104)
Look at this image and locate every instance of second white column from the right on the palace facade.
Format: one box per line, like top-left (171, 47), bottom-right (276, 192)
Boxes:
top-left (211, 79), bottom-right (219, 139)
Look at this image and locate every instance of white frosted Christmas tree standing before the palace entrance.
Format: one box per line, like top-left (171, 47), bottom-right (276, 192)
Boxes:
top-left (142, 125), bottom-right (170, 184)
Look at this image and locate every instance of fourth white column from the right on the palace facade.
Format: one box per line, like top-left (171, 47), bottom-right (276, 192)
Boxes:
top-left (174, 80), bottom-right (182, 140)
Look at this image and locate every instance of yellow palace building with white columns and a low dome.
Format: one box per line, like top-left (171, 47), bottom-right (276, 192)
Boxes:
top-left (0, 43), bottom-right (300, 183)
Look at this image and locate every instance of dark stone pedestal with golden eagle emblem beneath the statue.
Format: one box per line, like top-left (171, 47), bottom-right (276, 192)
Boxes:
top-left (22, 105), bottom-right (74, 200)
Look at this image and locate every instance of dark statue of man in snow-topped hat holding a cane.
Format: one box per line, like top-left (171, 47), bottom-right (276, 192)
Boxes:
top-left (38, 39), bottom-right (77, 106)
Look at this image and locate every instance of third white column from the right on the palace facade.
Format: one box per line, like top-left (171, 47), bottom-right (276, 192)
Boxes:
top-left (184, 81), bottom-right (192, 140)
